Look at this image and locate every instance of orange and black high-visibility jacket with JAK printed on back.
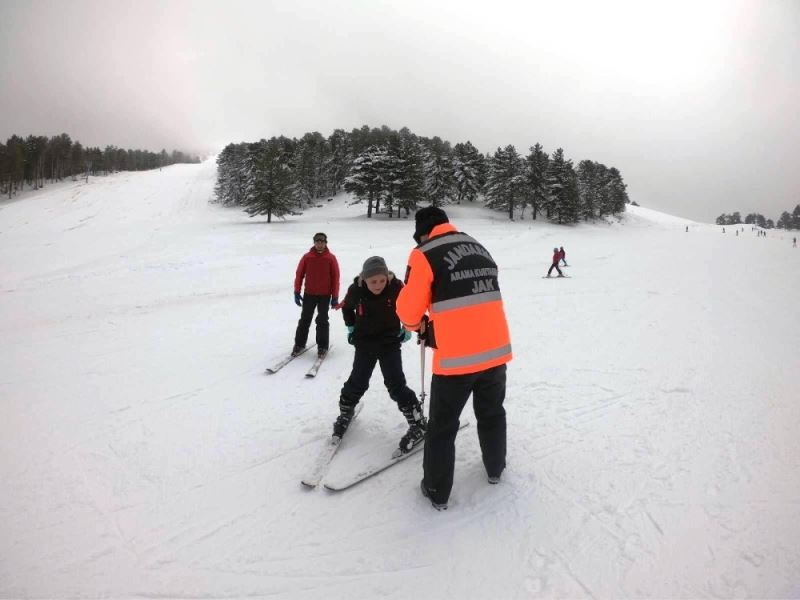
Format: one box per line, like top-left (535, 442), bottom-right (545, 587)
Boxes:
top-left (397, 223), bottom-right (511, 375)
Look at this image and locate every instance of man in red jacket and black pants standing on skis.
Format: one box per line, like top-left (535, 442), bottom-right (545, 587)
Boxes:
top-left (292, 233), bottom-right (339, 356)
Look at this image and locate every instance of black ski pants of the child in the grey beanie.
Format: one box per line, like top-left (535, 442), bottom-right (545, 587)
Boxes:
top-left (340, 343), bottom-right (417, 411)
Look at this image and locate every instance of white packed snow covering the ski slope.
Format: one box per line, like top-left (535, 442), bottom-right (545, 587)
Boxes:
top-left (0, 162), bottom-right (800, 600)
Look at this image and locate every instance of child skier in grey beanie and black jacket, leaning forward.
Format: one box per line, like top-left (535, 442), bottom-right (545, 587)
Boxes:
top-left (333, 256), bottom-right (426, 452)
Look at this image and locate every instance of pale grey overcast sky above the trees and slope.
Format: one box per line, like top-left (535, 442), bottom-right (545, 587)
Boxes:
top-left (0, 0), bottom-right (800, 221)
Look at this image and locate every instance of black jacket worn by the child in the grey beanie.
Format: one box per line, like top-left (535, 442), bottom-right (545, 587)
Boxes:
top-left (342, 272), bottom-right (403, 352)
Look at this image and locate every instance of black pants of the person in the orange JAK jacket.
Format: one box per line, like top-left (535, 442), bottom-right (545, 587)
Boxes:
top-left (422, 365), bottom-right (506, 503)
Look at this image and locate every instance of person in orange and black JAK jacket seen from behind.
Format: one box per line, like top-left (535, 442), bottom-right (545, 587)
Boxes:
top-left (397, 207), bottom-right (512, 509)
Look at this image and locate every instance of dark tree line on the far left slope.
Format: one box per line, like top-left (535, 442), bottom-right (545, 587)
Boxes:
top-left (0, 133), bottom-right (200, 198)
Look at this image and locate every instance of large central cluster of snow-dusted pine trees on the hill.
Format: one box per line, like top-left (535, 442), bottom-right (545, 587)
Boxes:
top-left (213, 125), bottom-right (629, 223)
